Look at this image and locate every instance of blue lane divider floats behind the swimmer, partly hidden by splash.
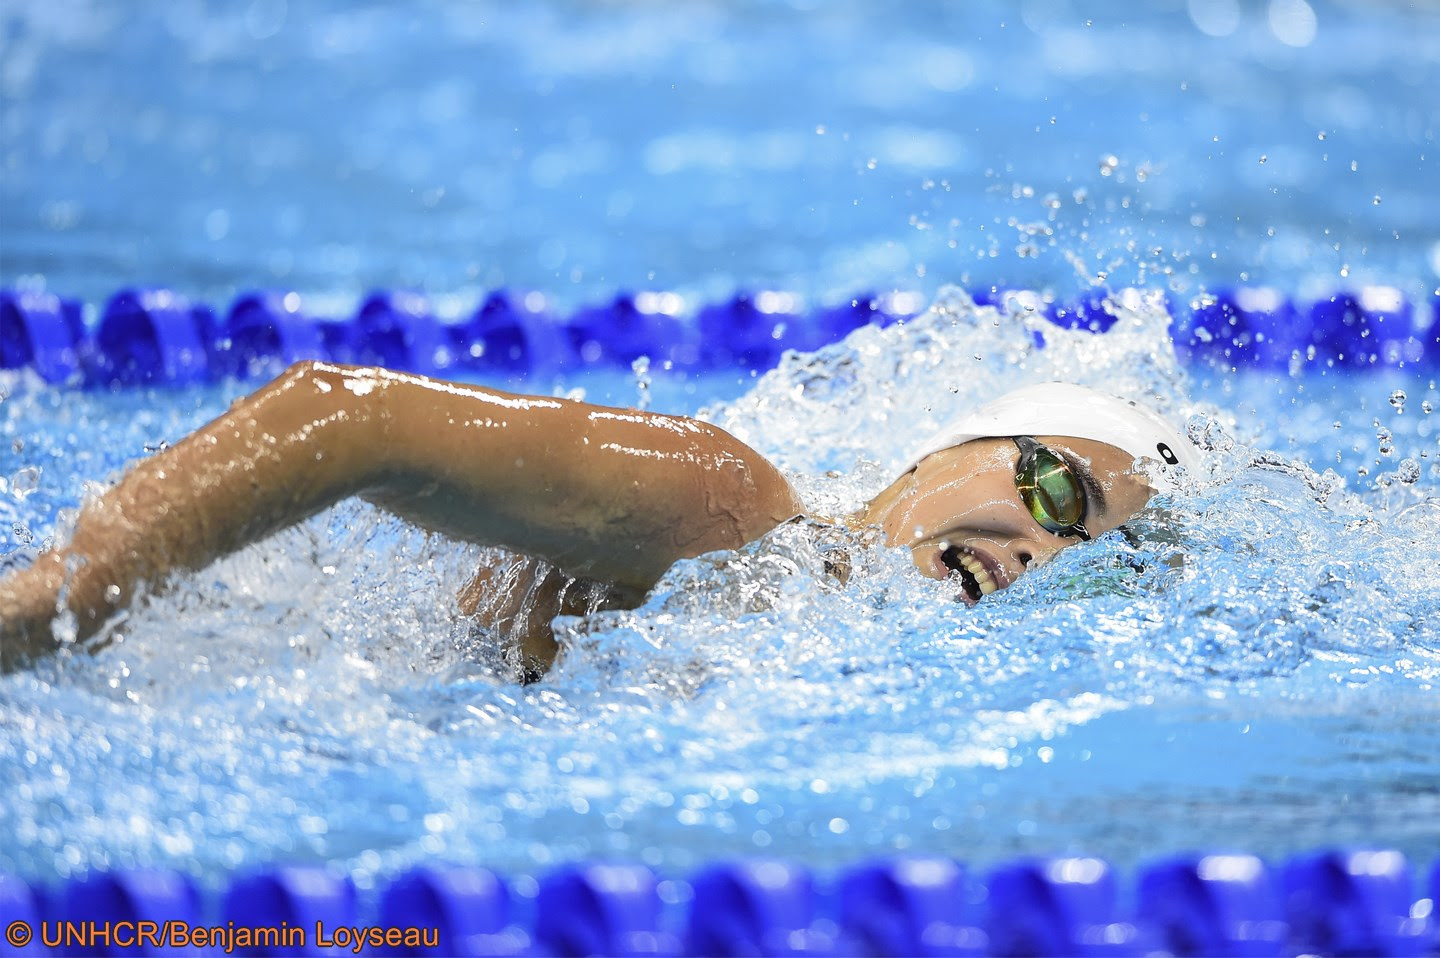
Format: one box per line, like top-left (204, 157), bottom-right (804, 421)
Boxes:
top-left (0, 287), bottom-right (1440, 386)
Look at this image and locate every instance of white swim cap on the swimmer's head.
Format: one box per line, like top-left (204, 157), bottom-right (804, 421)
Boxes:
top-left (906, 383), bottom-right (1200, 491)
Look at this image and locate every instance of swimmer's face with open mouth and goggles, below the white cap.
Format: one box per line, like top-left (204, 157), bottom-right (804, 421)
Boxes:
top-left (868, 437), bottom-right (1152, 605)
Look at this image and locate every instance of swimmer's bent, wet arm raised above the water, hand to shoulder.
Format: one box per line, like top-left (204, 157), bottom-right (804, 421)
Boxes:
top-left (0, 363), bottom-right (801, 666)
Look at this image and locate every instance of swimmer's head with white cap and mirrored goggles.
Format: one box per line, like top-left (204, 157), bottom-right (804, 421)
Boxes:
top-left (864, 383), bottom-right (1200, 602)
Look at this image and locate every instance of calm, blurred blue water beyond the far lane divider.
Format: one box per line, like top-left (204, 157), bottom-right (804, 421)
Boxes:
top-left (0, 0), bottom-right (1440, 303)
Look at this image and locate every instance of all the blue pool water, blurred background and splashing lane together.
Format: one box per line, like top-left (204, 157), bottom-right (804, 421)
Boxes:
top-left (0, 0), bottom-right (1440, 880)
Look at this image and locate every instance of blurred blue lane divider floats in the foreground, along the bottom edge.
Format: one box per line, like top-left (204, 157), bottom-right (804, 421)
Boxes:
top-left (0, 850), bottom-right (1440, 958)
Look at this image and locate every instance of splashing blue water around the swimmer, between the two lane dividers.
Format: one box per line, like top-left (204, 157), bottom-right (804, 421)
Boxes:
top-left (8, 297), bottom-right (1440, 876)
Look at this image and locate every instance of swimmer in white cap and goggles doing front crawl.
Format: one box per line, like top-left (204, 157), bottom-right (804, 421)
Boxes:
top-left (0, 362), bottom-right (1198, 679)
